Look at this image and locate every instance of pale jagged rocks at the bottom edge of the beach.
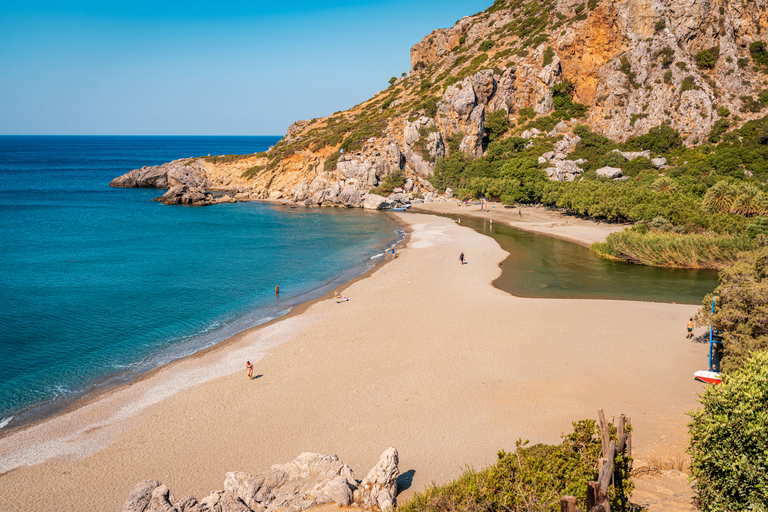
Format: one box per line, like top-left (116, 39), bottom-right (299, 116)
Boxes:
top-left (123, 448), bottom-right (400, 512)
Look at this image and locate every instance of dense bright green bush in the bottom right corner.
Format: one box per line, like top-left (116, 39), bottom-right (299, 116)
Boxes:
top-left (688, 352), bottom-right (768, 512)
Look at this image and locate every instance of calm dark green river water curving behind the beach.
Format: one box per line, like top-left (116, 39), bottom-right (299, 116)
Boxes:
top-left (452, 216), bottom-right (718, 305)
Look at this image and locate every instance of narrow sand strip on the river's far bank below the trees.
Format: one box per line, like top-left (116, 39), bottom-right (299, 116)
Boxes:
top-left (413, 201), bottom-right (627, 247)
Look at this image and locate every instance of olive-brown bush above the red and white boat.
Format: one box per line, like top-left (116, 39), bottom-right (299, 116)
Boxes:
top-left (697, 245), bottom-right (768, 370)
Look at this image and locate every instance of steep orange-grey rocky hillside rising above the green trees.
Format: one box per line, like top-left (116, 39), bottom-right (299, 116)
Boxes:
top-left (111, 0), bottom-right (768, 206)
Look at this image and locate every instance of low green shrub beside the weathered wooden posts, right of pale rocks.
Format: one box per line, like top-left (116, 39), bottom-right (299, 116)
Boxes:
top-left (397, 420), bottom-right (632, 512)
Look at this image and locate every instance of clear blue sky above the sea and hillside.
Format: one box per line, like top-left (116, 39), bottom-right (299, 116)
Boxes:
top-left (0, 0), bottom-right (492, 135)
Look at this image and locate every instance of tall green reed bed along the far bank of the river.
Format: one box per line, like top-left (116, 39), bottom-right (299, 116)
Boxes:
top-left (592, 228), bottom-right (754, 268)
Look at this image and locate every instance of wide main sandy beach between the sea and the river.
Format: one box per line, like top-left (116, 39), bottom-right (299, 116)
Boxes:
top-left (0, 213), bottom-right (707, 511)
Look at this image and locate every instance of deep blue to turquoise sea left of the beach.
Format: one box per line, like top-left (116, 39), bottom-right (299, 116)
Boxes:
top-left (0, 136), bottom-right (404, 432)
